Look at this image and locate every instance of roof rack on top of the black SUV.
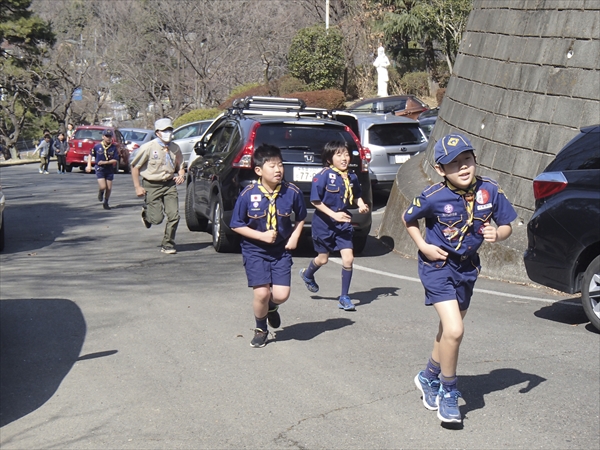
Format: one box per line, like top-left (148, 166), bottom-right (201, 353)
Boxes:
top-left (229, 96), bottom-right (328, 118)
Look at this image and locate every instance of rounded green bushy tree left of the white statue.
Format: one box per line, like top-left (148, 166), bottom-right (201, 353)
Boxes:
top-left (288, 25), bottom-right (345, 90)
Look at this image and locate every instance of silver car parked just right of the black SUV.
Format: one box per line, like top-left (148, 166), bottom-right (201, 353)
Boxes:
top-left (332, 111), bottom-right (427, 189)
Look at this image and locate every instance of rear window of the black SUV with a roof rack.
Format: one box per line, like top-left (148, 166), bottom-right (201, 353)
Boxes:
top-left (254, 124), bottom-right (357, 154)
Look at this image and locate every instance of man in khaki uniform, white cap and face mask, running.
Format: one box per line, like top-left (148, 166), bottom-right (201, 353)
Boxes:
top-left (131, 118), bottom-right (185, 254)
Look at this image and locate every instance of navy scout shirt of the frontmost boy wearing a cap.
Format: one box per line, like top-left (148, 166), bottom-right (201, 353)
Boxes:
top-left (404, 176), bottom-right (517, 256)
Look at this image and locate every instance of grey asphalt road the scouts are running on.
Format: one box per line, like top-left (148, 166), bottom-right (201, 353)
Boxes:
top-left (0, 163), bottom-right (600, 449)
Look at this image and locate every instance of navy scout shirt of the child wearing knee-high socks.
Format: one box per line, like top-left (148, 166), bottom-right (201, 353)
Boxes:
top-left (310, 167), bottom-right (362, 235)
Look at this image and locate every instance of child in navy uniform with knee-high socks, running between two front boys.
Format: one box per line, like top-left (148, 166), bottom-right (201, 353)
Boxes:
top-left (300, 141), bottom-right (369, 311)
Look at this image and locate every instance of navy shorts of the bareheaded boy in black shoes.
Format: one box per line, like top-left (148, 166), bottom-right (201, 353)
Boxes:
top-left (243, 251), bottom-right (294, 287)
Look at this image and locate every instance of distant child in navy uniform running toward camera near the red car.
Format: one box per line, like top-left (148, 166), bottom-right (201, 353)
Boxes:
top-left (85, 130), bottom-right (119, 209)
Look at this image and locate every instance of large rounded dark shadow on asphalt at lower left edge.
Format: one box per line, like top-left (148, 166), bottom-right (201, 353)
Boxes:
top-left (0, 299), bottom-right (86, 427)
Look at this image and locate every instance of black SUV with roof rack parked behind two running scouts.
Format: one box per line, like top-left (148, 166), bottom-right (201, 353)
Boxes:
top-left (185, 97), bottom-right (373, 253)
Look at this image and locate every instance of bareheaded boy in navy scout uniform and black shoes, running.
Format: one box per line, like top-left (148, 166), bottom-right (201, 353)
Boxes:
top-left (230, 144), bottom-right (306, 348)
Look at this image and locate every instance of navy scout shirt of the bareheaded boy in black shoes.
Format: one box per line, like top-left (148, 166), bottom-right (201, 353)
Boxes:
top-left (229, 181), bottom-right (306, 254)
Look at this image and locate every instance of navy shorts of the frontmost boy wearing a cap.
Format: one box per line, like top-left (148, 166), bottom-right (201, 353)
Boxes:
top-left (419, 252), bottom-right (481, 311)
